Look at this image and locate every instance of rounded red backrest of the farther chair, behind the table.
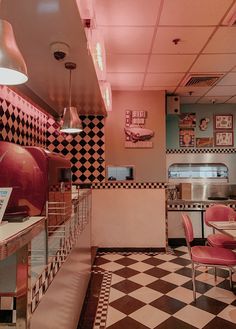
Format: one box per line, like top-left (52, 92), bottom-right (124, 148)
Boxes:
top-left (204, 204), bottom-right (235, 226)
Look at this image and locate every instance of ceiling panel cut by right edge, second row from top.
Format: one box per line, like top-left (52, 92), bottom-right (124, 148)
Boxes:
top-left (204, 26), bottom-right (236, 53)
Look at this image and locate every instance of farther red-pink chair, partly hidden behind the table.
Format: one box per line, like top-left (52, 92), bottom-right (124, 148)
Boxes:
top-left (205, 204), bottom-right (236, 249)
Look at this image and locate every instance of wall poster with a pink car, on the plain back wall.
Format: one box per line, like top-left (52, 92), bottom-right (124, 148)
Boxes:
top-left (124, 110), bottom-right (154, 148)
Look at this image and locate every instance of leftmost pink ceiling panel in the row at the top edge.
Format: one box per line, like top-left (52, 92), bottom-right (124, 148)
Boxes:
top-left (95, 0), bottom-right (161, 26)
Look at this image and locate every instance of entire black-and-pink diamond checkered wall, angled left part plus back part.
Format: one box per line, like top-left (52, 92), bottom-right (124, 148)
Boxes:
top-left (0, 86), bottom-right (105, 184)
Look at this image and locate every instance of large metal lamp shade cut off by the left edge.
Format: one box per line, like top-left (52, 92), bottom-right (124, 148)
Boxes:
top-left (0, 19), bottom-right (28, 85)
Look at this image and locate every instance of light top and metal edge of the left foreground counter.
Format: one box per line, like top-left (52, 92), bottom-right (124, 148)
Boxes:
top-left (0, 216), bottom-right (46, 260)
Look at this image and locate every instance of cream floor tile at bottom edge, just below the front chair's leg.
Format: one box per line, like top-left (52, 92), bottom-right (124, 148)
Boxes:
top-left (175, 305), bottom-right (215, 329)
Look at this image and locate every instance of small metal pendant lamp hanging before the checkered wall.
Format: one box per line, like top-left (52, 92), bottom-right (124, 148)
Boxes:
top-left (60, 62), bottom-right (83, 134)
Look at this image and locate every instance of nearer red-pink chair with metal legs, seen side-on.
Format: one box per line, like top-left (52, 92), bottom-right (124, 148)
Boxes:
top-left (182, 214), bottom-right (236, 301)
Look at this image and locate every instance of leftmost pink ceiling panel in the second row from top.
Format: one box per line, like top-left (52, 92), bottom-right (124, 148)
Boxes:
top-left (102, 27), bottom-right (154, 54)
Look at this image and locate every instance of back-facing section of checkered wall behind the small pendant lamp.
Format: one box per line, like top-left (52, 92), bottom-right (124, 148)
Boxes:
top-left (47, 115), bottom-right (105, 184)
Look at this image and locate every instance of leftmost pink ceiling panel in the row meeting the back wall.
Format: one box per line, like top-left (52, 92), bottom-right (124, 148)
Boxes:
top-left (107, 73), bottom-right (144, 90)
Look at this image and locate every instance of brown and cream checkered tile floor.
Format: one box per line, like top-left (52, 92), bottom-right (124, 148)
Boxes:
top-left (91, 247), bottom-right (236, 329)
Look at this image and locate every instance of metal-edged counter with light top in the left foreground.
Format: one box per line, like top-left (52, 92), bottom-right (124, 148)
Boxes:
top-left (0, 216), bottom-right (46, 329)
